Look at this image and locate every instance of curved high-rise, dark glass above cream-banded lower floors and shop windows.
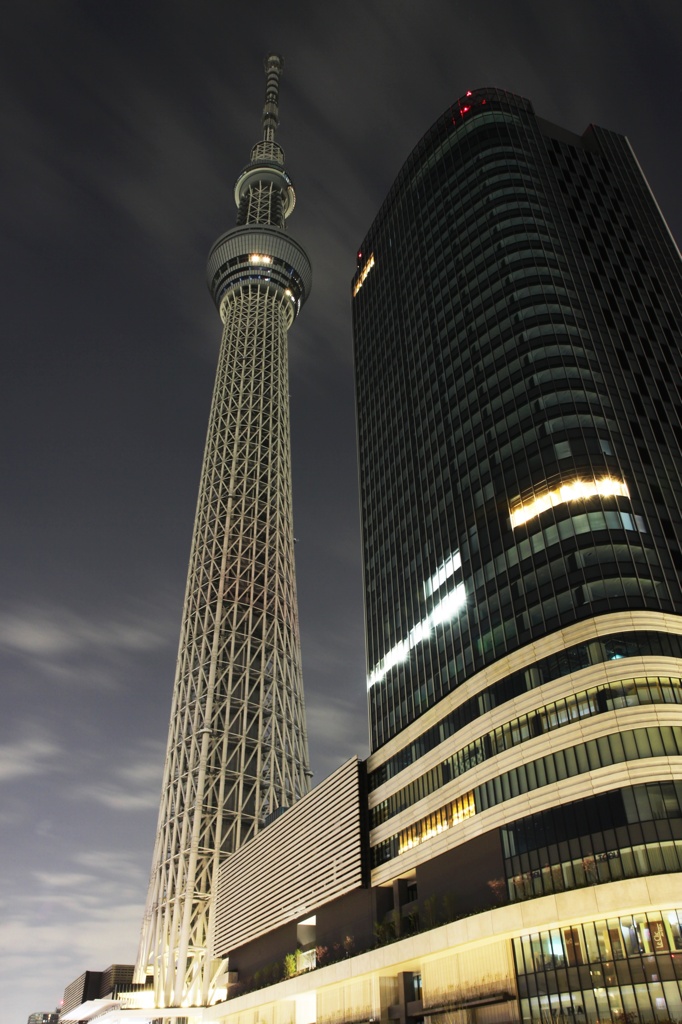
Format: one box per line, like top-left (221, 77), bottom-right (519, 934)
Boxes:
top-left (352, 89), bottom-right (682, 1020)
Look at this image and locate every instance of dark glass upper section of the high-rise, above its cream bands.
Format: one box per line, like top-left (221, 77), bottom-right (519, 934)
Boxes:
top-left (353, 89), bottom-right (682, 751)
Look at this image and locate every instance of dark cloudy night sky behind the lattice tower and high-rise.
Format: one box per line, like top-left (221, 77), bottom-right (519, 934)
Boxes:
top-left (0, 0), bottom-right (682, 1024)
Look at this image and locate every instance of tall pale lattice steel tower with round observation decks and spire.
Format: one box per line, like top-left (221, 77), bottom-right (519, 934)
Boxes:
top-left (136, 54), bottom-right (311, 1007)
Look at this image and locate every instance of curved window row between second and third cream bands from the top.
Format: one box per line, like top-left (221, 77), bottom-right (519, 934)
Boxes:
top-left (370, 676), bottom-right (682, 828)
